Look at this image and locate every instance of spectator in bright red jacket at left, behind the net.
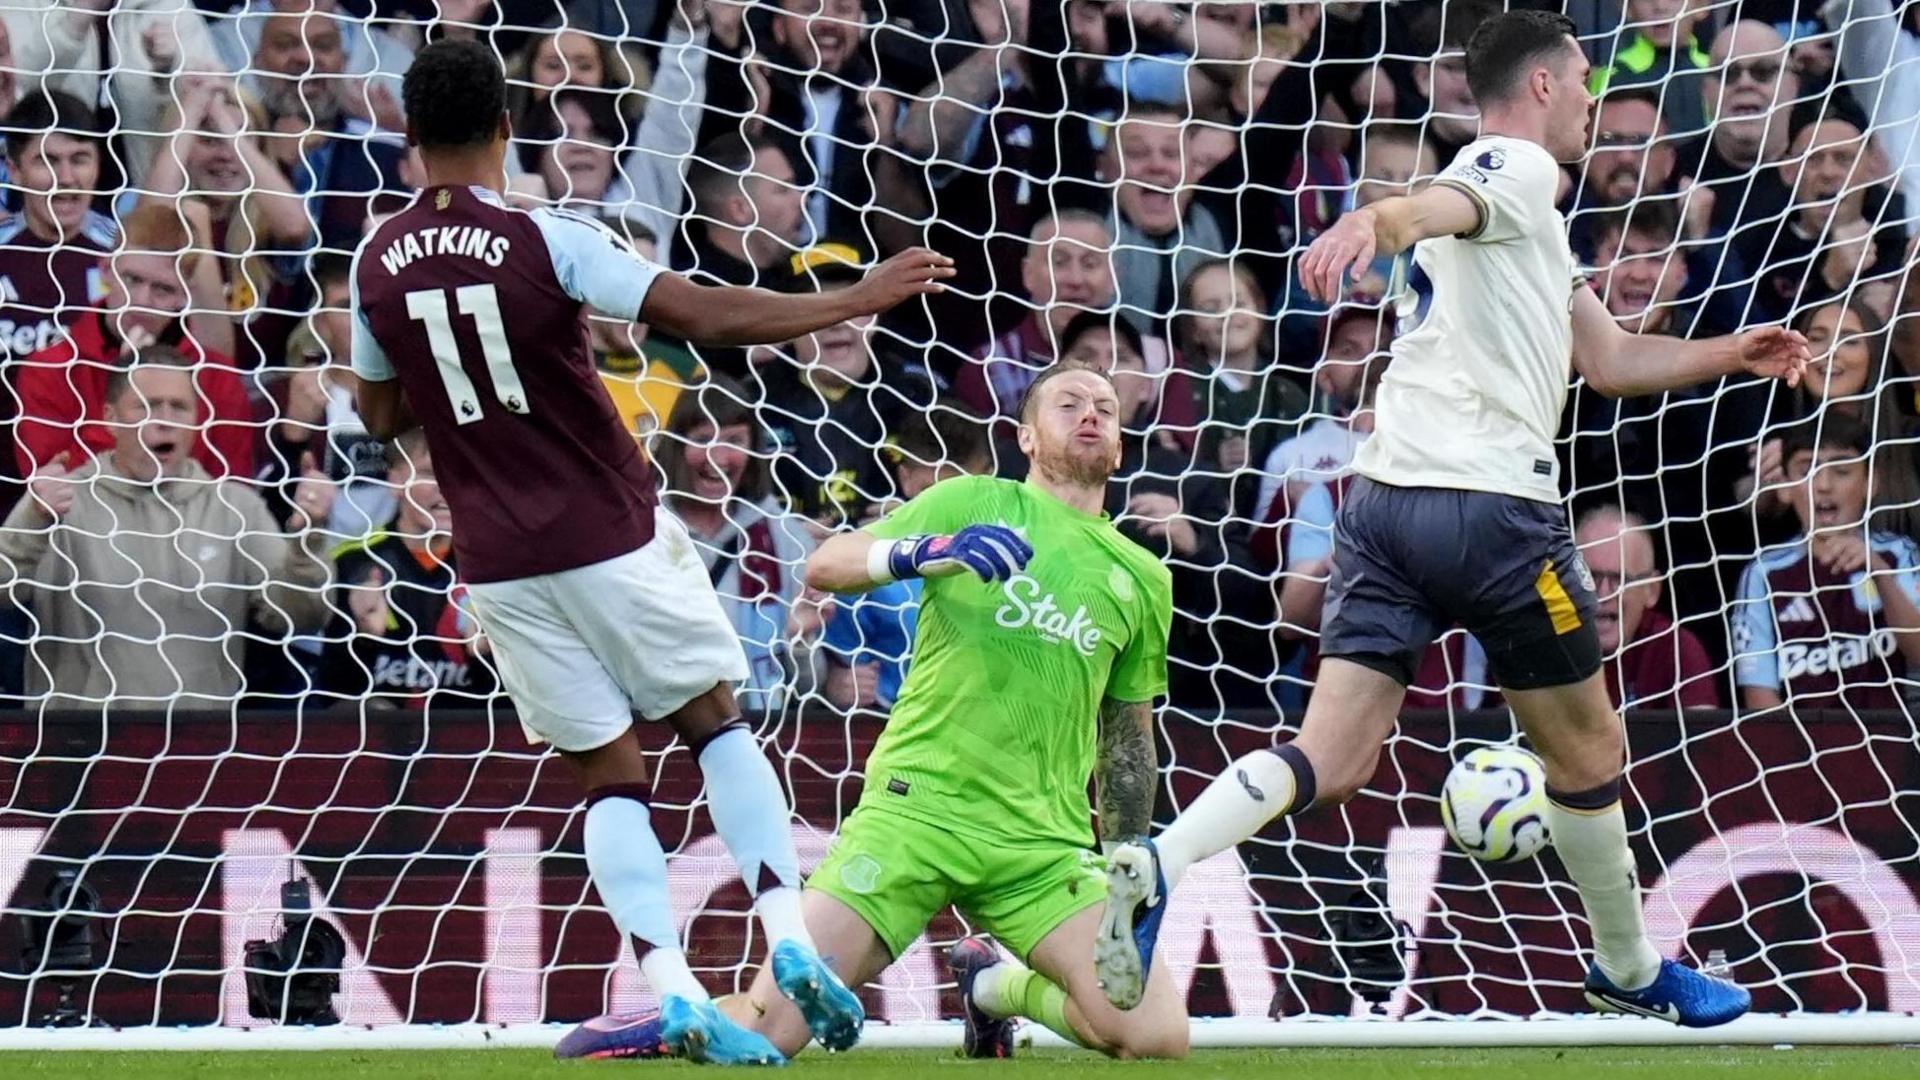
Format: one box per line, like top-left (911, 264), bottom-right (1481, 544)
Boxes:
top-left (13, 204), bottom-right (255, 477)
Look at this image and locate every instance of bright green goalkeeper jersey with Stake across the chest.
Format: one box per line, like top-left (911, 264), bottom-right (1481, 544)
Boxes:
top-left (860, 477), bottom-right (1173, 847)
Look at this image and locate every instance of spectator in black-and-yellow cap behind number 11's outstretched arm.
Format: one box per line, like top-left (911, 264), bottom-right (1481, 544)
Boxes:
top-left (756, 244), bottom-right (939, 528)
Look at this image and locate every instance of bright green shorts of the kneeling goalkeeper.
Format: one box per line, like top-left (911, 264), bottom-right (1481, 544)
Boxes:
top-left (806, 807), bottom-right (1106, 961)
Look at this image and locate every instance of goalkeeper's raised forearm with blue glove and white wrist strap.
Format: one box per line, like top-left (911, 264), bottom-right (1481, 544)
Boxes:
top-left (806, 525), bottom-right (1033, 592)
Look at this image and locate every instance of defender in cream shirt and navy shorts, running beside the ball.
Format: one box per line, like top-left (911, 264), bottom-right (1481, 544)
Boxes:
top-left (1094, 12), bottom-right (1809, 1026)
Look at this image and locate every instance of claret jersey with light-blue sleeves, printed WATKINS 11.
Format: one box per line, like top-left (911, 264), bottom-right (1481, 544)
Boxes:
top-left (351, 186), bottom-right (662, 582)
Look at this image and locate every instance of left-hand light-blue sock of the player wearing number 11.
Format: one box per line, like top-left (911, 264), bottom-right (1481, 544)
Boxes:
top-left (586, 792), bottom-right (707, 1001)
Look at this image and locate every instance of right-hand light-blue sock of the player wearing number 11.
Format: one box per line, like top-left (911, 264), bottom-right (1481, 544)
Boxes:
top-left (701, 726), bottom-right (814, 949)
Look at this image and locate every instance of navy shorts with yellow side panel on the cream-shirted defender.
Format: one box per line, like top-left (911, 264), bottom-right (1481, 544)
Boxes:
top-left (1321, 479), bottom-right (1599, 690)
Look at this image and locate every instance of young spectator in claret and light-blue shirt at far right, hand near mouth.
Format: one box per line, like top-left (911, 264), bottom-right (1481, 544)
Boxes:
top-left (1734, 417), bottom-right (1920, 709)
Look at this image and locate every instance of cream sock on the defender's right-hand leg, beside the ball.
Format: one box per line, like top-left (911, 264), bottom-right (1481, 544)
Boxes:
top-left (1548, 799), bottom-right (1661, 990)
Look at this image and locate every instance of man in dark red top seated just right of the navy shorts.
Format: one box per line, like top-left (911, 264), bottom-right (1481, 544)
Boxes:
top-left (1572, 505), bottom-right (1720, 711)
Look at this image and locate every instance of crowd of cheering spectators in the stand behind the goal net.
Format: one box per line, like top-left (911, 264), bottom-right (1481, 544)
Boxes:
top-left (0, 0), bottom-right (1920, 717)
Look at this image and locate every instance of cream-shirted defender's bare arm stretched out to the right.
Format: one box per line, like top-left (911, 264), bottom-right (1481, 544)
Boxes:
top-left (1572, 286), bottom-right (1812, 398)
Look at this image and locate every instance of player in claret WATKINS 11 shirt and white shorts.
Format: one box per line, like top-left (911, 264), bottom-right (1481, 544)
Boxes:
top-left (351, 42), bottom-right (952, 1063)
